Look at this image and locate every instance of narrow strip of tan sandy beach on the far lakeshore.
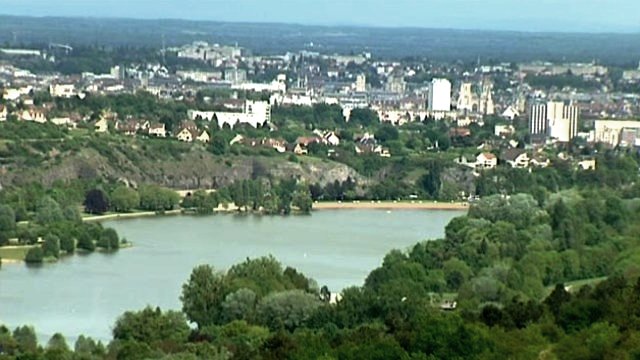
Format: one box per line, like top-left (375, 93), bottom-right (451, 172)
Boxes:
top-left (313, 200), bottom-right (469, 210)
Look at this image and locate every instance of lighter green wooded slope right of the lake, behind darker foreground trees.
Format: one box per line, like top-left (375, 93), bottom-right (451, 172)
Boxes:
top-left (365, 190), bottom-right (638, 310)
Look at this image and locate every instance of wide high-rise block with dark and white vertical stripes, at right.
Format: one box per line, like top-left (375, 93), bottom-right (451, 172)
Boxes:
top-left (529, 101), bottom-right (580, 142)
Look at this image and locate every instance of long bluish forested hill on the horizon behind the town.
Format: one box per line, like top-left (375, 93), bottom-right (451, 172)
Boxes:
top-left (0, 16), bottom-right (640, 65)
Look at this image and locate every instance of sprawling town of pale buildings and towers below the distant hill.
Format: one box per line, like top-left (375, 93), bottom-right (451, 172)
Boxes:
top-left (0, 42), bottom-right (640, 152)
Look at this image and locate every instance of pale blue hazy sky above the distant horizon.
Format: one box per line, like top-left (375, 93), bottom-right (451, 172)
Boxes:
top-left (0, 0), bottom-right (640, 32)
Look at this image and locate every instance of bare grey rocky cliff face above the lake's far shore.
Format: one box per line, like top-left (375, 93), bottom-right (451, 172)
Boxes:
top-left (0, 148), bottom-right (366, 189)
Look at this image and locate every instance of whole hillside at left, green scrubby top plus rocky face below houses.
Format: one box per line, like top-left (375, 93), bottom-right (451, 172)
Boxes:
top-left (0, 135), bottom-right (366, 189)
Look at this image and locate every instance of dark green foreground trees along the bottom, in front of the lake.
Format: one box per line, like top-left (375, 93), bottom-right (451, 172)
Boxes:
top-left (0, 258), bottom-right (640, 359)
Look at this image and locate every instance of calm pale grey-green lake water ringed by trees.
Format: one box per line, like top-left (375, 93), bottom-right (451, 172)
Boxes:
top-left (0, 210), bottom-right (463, 341)
